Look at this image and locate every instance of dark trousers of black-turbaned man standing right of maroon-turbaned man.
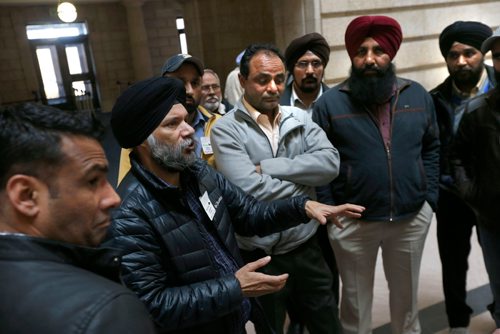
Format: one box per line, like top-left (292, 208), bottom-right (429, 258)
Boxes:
top-left (436, 189), bottom-right (476, 327)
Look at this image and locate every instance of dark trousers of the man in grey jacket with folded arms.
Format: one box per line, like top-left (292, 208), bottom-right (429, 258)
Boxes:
top-left (241, 237), bottom-right (341, 334)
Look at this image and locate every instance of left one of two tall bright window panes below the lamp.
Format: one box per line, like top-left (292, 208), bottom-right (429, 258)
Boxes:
top-left (36, 46), bottom-right (65, 99)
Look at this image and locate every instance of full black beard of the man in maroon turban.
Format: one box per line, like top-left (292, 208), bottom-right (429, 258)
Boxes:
top-left (349, 63), bottom-right (396, 105)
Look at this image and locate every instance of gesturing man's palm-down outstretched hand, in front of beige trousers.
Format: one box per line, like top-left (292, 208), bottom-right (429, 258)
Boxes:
top-left (306, 201), bottom-right (365, 228)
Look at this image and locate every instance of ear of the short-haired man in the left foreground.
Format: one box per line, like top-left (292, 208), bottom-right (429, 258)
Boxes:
top-left (5, 174), bottom-right (43, 217)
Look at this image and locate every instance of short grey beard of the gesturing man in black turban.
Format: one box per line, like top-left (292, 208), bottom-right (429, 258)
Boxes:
top-left (147, 134), bottom-right (196, 172)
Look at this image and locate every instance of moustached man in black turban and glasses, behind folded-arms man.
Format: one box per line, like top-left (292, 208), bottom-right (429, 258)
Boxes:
top-left (280, 32), bottom-right (330, 115)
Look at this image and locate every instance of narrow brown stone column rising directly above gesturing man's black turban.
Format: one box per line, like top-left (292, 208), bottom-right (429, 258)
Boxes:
top-left (122, 0), bottom-right (153, 80)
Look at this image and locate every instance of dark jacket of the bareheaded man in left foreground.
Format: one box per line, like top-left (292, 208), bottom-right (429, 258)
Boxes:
top-left (0, 234), bottom-right (154, 334)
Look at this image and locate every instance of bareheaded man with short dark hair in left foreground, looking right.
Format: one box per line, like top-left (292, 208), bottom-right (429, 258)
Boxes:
top-left (0, 104), bottom-right (155, 334)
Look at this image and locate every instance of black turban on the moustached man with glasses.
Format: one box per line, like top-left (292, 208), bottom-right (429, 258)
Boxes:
top-left (285, 32), bottom-right (330, 73)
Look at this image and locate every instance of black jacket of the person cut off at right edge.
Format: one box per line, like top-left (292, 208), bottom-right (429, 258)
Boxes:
top-left (450, 87), bottom-right (500, 233)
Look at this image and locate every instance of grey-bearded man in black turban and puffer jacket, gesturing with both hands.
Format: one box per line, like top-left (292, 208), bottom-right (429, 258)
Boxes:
top-left (106, 78), bottom-right (363, 333)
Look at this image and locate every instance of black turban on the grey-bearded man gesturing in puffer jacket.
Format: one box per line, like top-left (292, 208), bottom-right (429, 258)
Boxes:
top-left (110, 77), bottom-right (186, 148)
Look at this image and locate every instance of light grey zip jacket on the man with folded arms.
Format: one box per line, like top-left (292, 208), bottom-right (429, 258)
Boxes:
top-left (210, 100), bottom-right (340, 254)
